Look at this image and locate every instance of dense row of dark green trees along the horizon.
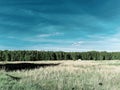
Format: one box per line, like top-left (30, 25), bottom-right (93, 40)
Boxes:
top-left (0, 50), bottom-right (120, 61)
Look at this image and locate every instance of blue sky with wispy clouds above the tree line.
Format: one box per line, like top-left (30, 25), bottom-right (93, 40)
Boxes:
top-left (0, 0), bottom-right (120, 51)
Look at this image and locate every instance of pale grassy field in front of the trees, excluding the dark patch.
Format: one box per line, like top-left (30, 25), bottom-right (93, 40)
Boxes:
top-left (0, 60), bottom-right (120, 90)
